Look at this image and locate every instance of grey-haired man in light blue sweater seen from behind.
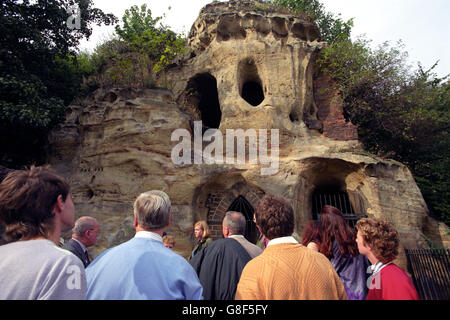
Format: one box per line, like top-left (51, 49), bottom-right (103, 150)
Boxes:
top-left (86, 190), bottom-right (203, 300)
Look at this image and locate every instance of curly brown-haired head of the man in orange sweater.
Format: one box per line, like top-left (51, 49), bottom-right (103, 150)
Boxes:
top-left (255, 194), bottom-right (295, 240)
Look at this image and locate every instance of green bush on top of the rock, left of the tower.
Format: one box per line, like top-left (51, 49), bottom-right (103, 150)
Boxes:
top-left (81, 4), bottom-right (186, 87)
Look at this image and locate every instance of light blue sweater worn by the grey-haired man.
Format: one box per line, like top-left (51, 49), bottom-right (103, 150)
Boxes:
top-left (86, 238), bottom-right (203, 300)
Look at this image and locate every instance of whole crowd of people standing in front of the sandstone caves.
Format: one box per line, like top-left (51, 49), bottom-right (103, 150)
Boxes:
top-left (0, 167), bottom-right (418, 300)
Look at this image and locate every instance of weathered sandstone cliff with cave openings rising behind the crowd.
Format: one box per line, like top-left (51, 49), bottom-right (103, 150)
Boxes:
top-left (50, 1), bottom-right (448, 266)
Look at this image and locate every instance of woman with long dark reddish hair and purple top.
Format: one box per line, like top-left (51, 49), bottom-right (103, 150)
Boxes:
top-left (319, 205), bottom-right (370, 300)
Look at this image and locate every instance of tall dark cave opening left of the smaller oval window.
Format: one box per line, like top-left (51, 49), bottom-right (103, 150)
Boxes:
top-left (186, 73), bottom-right (222, 129)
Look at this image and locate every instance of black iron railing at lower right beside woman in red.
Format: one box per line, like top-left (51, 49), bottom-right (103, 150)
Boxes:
top-left (405, 249), bottom-right (450, 300)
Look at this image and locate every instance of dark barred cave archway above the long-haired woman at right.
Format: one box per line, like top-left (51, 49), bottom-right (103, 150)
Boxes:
top-left (312, 187), bottom-right (367, 227)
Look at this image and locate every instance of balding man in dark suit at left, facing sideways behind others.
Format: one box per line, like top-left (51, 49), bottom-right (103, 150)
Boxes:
top-left (63, 216), bottom-right (99, 268)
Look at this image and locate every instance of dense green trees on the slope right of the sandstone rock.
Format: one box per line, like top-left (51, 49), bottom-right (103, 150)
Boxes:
top-left (317, 38), bottom-right (450, 223)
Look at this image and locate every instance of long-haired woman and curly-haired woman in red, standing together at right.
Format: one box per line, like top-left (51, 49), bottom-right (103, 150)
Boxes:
top-left (302, 205), bottom-right (419, 300)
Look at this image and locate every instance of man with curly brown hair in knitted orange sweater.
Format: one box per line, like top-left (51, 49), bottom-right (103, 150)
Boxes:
top-left (235, 195), bottom-right (347, 300)
